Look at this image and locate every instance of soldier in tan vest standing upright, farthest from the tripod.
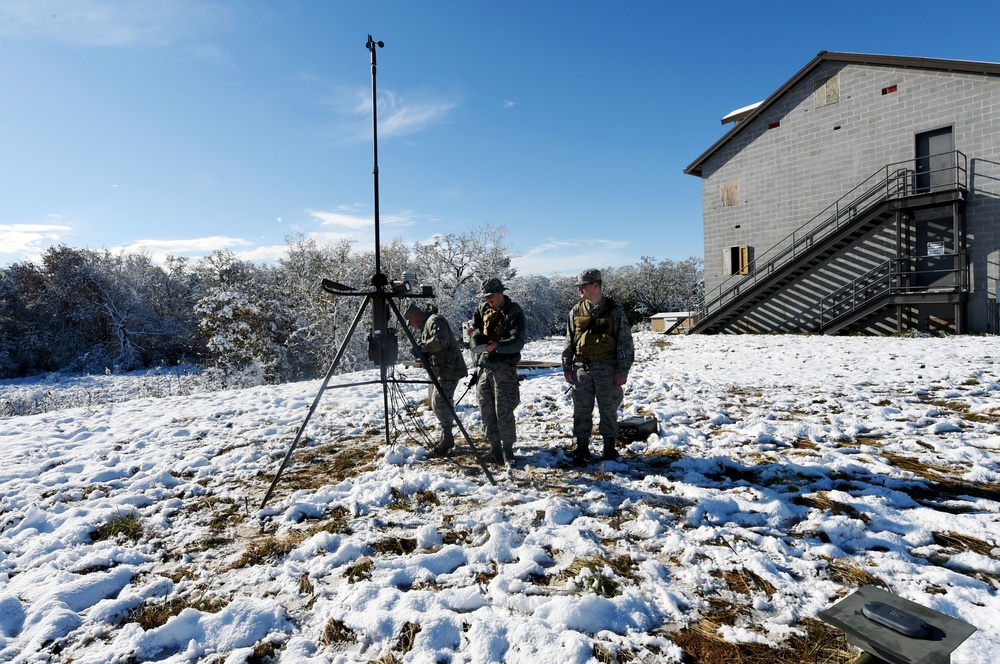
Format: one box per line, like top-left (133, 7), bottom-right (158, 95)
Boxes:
top-left (562, 270), bottom-right (635, 466)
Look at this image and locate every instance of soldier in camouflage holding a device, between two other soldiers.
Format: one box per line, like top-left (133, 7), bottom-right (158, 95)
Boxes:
top-left (469, 278), bottom-right (526, 465)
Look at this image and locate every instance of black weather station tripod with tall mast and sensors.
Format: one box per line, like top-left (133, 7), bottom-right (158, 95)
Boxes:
top-left (260, 35), bottom-right (496, 509)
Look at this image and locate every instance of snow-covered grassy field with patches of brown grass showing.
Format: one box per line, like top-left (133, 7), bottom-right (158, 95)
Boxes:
top-left (0, 333), bottom-right (1000, 664)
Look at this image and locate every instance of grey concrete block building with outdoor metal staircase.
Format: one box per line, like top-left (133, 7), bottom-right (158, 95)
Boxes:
top-left (685, 51), bottom-right (1000, 334)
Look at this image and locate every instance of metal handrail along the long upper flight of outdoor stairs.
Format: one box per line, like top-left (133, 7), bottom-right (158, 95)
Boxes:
top-left (696, 150), bottom-right (969, 321)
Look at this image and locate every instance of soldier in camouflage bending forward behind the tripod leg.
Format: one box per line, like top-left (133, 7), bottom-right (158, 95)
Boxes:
top-left (403, 303), bottom-right (469, 456)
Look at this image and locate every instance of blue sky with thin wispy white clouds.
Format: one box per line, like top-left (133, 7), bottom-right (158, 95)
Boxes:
top-left (0, 0), bottom-right (1000, 274)
